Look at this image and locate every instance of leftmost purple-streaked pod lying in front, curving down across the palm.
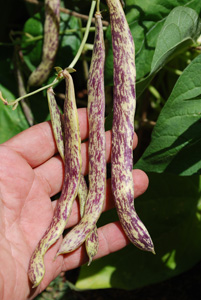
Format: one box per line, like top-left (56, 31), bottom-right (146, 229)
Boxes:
top-left (28, 71), bottom-right (81, 287)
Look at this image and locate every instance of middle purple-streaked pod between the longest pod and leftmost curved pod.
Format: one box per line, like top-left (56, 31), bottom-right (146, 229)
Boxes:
top-left (57, 13), bottom-right (106, 255)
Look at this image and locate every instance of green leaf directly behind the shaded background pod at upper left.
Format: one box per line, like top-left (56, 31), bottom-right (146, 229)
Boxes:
top-left (22, 9), bottom-right (81, 75)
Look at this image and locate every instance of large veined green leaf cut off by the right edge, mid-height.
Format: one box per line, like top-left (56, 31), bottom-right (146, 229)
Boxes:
top-left (136, 55), bottom-right (201, 175)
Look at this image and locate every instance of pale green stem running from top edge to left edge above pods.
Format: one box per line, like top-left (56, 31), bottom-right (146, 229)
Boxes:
top-left (0, 0), bottom-right (97, 110)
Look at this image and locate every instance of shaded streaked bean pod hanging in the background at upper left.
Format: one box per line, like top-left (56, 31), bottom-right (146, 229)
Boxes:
top-left (28, 0), bottom-right (60, 86)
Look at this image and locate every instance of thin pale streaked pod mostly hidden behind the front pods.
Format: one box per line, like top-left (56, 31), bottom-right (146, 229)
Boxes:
top-left (47, 88), bottom-right (98, 264)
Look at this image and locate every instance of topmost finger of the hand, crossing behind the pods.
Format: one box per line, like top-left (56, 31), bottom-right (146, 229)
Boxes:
top-left (4, 108), bottom-right (89, 168)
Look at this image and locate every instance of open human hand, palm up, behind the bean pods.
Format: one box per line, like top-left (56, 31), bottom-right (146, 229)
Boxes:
top-left (0, 109), bottom-right (148, 300)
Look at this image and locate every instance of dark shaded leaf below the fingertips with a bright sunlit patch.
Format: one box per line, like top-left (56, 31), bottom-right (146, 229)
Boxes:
top-left (76, 174), bottom-right (201, 290)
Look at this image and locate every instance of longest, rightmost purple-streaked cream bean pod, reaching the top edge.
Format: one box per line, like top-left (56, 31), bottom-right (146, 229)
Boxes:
top-left (106, 0), bottom-right (154, 253)
